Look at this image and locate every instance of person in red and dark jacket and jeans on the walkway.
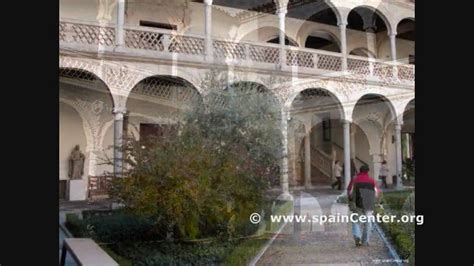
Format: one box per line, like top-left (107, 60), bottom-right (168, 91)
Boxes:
top-left (347, 165), bottom-right (380, 246)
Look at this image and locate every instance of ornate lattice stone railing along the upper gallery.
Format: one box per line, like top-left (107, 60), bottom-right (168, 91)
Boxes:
top-left (59, 21), bottom-right (415, 84)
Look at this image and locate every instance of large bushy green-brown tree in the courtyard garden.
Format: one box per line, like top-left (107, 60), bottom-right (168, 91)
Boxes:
top-left (110, 70), bottom-right (281, 239)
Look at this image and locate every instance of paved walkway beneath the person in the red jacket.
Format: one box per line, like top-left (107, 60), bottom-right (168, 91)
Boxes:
top-left (257, 188), bottom-right (394, 265)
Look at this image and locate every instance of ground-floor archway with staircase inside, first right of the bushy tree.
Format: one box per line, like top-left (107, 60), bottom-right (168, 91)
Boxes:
top-left (288, 88), bottom-right (344, 188)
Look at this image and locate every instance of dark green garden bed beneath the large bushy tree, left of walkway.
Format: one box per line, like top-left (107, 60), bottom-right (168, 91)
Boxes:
top-left (66, 202), bottom-right (292, 265)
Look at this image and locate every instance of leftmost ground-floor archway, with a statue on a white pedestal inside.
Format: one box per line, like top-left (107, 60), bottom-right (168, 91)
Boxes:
top-left (59, 68), bottom-right (114, 200)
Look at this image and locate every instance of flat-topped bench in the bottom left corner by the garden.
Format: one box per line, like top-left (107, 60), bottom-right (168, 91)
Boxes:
top-left (60, 238), bottom-right (118, 266)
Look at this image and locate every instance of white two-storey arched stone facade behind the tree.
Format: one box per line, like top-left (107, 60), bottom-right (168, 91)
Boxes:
top-left (59, 0), bottom-right (415, 200)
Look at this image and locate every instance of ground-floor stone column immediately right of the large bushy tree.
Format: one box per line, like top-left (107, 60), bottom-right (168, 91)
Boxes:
top-left (279, 110), bottom-right (293, 200)
